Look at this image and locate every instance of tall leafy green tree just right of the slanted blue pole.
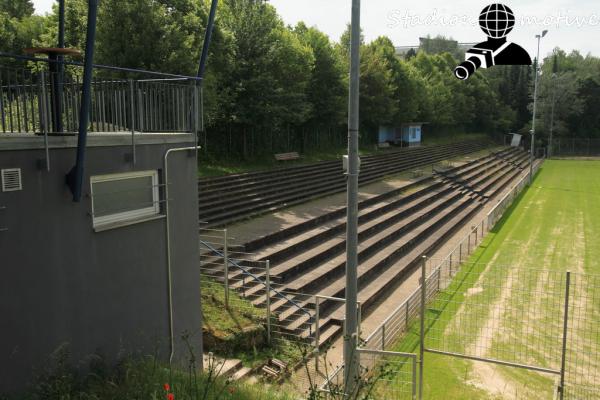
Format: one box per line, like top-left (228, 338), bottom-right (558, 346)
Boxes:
top-left (212, 0), bottom-right (314, 157)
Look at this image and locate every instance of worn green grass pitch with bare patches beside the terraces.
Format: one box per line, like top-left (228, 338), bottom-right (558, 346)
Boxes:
top-left (395, 160), bottom-right (600, 400)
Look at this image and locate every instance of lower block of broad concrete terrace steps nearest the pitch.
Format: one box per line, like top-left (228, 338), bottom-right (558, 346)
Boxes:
top-left (202, 148), bottom-right (527, 341)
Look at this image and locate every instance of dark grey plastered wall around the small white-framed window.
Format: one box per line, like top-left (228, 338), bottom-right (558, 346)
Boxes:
top-left (0, 134), bottom-right (201, 393)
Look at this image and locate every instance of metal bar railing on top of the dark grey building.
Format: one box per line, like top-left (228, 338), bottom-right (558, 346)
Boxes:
top-left (0, 66), bottom-right (201, 134)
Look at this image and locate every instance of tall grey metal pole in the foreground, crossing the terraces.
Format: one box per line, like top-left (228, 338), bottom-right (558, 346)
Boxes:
top-left (344, 0), bottom-right (360, 397)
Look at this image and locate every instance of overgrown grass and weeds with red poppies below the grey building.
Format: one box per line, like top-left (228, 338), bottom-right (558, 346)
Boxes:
top-left (0, 347), bottom-right (296, 400)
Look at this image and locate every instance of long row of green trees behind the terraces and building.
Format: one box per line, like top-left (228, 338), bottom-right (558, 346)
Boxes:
top-left (0, 0), bottom-right (600, 157)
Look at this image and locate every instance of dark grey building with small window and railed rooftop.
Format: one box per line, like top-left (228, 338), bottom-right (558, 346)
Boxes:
top-left (0, 69), bottom-right (202, 394)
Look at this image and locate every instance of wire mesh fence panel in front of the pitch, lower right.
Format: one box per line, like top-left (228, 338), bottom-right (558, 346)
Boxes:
top-left (421, 263), bottom-right (600, 399)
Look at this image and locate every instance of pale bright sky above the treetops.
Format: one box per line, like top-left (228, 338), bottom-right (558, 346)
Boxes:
top-left (33, 0), bottom-right (600, 56)
